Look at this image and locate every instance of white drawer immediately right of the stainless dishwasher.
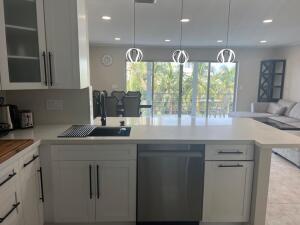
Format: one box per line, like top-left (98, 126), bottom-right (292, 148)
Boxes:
top-left (205, 145), bottom-right (254, 160)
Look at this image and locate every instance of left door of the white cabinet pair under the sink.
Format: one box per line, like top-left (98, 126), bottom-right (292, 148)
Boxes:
top-left (52, 161), bottom-right (95, 223)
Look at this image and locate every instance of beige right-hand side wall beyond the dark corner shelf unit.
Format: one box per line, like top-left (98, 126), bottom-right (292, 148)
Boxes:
top-left (275, 46), bottom-right (300, 102)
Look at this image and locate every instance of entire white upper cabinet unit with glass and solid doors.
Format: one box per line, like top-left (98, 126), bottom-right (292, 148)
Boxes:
top-left (0, 0), bottom-right (89, 90)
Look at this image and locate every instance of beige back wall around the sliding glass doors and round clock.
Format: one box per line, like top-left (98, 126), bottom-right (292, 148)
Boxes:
top-left (90, 46), bottom-right (273, 111)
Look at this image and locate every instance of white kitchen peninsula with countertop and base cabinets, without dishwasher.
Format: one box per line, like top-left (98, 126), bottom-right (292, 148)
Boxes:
top-left (1, 117), bottom-right (300, 225)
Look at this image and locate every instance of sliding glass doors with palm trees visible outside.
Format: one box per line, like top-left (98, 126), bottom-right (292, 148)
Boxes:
top-left (126, 62), bottom-right (236, 117)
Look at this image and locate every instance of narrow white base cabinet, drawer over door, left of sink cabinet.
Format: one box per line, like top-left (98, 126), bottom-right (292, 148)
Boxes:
top-left (20, 153), bottom-right (43, 225)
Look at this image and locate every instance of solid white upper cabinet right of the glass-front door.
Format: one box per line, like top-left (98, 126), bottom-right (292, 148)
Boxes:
top-left (44, 0), bottom-right (89, 89)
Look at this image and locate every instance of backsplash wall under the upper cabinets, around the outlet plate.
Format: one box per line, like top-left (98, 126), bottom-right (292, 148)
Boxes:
top-left (6, 88), bottom-right (92, 125)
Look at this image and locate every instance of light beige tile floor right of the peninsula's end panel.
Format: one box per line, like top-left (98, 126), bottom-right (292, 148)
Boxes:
top-left (266, 154), bottom-right (300, 225)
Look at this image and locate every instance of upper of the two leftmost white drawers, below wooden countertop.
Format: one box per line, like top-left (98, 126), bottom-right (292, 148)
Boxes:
top-left (0, 163), bottom-right (19, 195)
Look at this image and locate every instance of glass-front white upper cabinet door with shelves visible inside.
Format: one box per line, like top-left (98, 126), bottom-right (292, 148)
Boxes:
top-left (0, 0), bottom-right (47, 90)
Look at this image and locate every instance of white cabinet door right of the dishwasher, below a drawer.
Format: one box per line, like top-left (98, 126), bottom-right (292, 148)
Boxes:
top-left (203, 161), bottom-right (253, 222)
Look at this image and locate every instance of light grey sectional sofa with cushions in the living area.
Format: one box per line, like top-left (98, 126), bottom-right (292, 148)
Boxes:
top-left (229, 99), bottom-right (300, 168)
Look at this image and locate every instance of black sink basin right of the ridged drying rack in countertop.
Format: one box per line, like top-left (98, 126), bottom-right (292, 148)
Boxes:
top-left (88, 127), bottom-right (131, 137)
